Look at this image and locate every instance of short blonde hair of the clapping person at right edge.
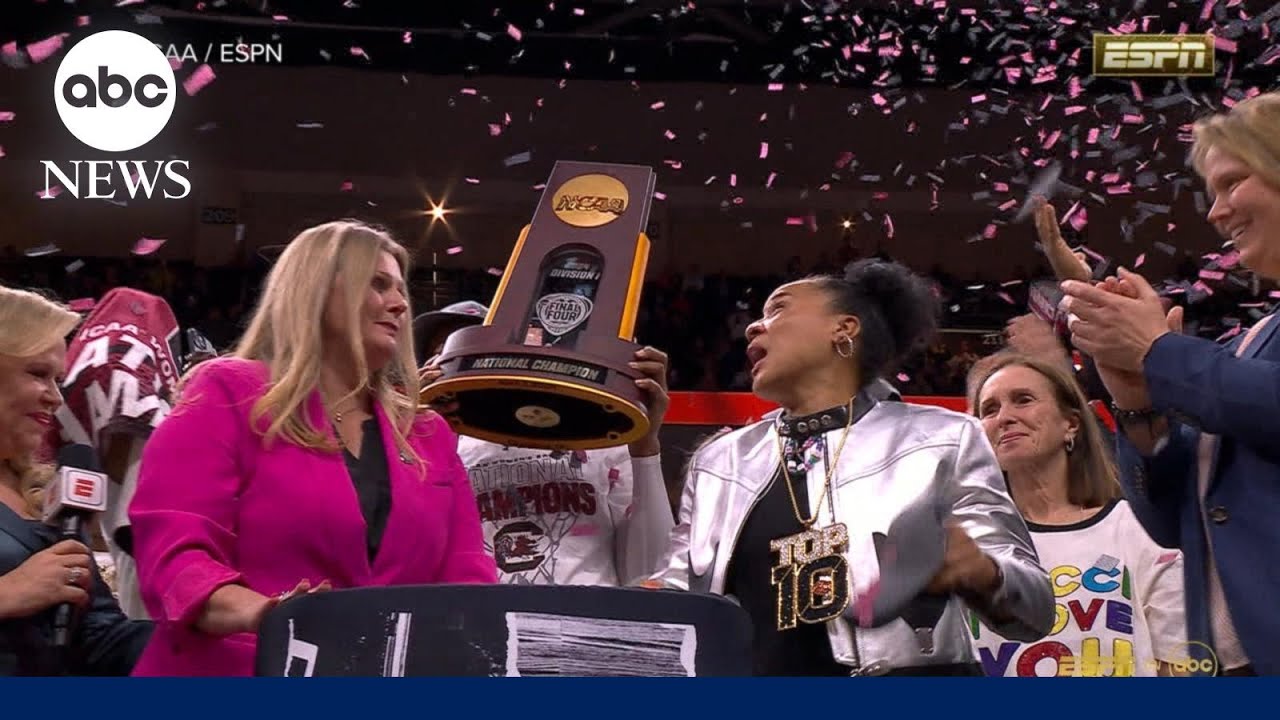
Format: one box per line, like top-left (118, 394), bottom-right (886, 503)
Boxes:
top-left (1192, 91), bottom-right (1280, 188)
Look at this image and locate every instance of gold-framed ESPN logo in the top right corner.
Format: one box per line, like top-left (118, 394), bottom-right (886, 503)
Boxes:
top-left (1093, 33), bottom-right (1216, 77)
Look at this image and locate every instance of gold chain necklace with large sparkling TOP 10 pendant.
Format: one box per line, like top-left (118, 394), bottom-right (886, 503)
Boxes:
top-left (769, 398), bottom-right (854, 630)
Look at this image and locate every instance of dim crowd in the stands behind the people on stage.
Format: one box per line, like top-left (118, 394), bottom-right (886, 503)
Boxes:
top-left (0, 247), bottom-right (1252, 396)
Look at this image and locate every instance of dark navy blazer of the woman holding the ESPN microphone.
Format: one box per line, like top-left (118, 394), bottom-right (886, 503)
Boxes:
top-left (0, 503), bottom-right (152, 676)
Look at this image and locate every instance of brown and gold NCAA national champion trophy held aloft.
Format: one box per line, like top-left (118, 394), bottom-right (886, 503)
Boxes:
top-left (420, 161), bottom-right (657, 450)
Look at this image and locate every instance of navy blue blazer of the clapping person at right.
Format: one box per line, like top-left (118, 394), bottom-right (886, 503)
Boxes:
top-left (1116, 318), bottom-right (1280, 675)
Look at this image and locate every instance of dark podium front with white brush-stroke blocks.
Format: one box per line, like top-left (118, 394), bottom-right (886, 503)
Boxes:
top-left (255, 585), bottom-right (751, 678)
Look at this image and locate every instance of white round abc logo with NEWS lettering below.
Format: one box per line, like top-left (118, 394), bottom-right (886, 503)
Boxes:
top-left (40, 29), bottom-right (191, 200)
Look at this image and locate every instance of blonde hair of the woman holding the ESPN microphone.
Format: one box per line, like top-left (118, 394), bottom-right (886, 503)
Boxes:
top-left (0, 286), bottom-right (81, 515)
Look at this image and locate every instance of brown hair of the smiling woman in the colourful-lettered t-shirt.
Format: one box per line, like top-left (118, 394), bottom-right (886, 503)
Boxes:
top-left (966, 350), bottom-right (1123, 507)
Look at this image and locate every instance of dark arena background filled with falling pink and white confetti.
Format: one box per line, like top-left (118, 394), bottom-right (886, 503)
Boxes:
top-left (0, 0), bottom-right (1280, 676)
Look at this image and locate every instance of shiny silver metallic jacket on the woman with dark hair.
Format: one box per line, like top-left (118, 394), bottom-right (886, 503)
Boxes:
top-left (654, 394), bottom-right (1053, 675)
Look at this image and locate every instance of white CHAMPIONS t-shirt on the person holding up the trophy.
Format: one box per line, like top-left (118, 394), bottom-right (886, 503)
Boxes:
top-left (458, 437), bottom-right (675, 585)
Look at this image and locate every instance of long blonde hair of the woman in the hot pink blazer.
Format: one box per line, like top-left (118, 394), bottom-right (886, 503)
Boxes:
top-left (230, 220), bottom-right (420, 461)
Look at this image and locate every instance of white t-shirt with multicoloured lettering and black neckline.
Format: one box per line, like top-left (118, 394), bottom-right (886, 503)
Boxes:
top-left (969, 500), bottom-right (1188, 678)
